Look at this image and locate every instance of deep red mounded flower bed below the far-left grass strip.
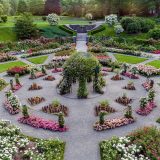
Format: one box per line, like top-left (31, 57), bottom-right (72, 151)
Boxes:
top-left (7, 67), bottom-right (29, 76)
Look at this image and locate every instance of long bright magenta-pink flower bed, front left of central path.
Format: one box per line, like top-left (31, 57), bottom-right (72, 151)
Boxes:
top-left (18, 116), bottom-right (68, 132)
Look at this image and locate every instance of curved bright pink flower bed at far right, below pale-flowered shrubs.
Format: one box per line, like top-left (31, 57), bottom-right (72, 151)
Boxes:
top-left (136, 102), bottom-right (156, 116)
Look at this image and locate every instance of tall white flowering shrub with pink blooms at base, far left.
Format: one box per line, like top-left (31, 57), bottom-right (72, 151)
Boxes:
top-left (4, 91), bottom-right (21, 115)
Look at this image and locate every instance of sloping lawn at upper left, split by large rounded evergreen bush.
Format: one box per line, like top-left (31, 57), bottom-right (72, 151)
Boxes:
top-left (0, 16), bottom-right (84, 42)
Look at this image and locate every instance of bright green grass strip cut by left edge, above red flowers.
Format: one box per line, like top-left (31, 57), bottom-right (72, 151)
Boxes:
top-left (0, 61), bottom-right (26, 73)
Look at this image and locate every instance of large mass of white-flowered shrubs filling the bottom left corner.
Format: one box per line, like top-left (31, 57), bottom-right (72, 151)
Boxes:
top-left (0, 120), bottom-right (65, 160)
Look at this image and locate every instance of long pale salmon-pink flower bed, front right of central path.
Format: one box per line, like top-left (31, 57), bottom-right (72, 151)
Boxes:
top-left (93, 118), bottom-right (135, 131)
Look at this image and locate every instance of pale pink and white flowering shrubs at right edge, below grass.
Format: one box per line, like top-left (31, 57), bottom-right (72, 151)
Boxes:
top-left (136, 65), bottom-right (160, 77)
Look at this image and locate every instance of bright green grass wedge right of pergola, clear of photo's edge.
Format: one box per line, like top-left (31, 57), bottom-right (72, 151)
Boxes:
top-left (114, 54), bottom-right (147, 64)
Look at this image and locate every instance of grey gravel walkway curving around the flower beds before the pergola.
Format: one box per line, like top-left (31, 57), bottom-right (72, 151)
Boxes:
top-left (0, 70), bottom-right (160, 160)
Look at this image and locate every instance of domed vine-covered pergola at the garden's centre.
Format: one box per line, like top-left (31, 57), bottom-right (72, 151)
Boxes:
top-left (58, 52), bottom-right (104, 98)
